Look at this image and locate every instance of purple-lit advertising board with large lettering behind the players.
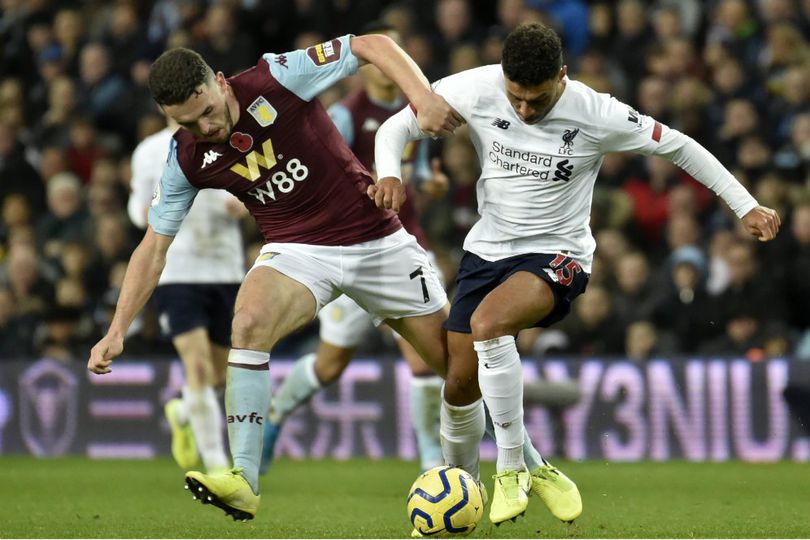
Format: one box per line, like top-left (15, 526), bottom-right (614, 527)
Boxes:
top-left (0, 358), bottom-right (810, 462)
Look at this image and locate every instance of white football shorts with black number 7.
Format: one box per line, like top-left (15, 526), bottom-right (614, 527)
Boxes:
top-left (251, 229), bottom-right (447, 326)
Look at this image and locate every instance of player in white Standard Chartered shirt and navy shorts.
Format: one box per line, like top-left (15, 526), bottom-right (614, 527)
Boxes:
top-left (369, 24), bottom-right (780, 523)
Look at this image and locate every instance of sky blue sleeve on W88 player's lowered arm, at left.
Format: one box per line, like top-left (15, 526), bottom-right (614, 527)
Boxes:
top-left (149, 139), bottom-right (199, 236)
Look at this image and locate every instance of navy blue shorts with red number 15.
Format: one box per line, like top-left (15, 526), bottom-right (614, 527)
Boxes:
top-left (444, 252), bottom-right (588, 334)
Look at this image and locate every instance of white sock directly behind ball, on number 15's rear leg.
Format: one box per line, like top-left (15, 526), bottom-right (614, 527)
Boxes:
top-left (441, 392), bottom-right (484, 481)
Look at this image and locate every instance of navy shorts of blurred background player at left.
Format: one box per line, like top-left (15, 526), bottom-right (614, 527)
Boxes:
top-left (152, 283), bottom-right (239, 347)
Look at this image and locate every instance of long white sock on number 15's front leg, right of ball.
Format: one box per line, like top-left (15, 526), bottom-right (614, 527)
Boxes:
top-left (473, 336), bottom-right (525, 472)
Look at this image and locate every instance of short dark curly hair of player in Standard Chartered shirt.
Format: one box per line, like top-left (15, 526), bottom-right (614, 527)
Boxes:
top-left (501, 23), bottom-right (562, 86)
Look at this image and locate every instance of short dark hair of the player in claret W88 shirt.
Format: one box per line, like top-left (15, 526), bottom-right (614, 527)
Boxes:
top-left (149, 47), bottom-right (214, 105)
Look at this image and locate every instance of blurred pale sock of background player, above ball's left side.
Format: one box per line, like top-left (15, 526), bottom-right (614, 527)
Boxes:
top-left (411, 375), bottom-right (444, 471)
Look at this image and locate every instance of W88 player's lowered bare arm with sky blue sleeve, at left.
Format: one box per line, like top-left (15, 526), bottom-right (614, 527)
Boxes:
top-left (87, 142), bottom-right (197, 374)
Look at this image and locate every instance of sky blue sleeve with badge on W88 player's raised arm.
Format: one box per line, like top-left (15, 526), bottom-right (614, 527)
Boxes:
top-left (262, 35), bottom-right (358, 101)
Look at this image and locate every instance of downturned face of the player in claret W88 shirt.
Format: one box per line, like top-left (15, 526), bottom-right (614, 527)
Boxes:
top-left (163, 72), bottom-right (233, 143)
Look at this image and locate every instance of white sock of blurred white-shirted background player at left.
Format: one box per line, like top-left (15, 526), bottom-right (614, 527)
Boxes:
top-left (183, 386), bottom-right (230, 471)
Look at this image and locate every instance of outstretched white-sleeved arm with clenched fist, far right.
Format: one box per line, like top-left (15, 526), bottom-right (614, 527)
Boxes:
top-left (600, 98), bottom-right (781, 242)
